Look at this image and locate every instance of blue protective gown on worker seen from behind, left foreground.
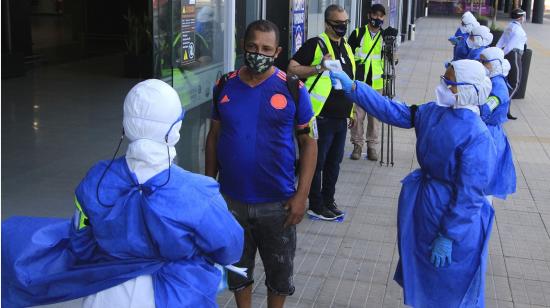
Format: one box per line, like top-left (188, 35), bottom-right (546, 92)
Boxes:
top-left (2, 157), bottom-right (243, 308)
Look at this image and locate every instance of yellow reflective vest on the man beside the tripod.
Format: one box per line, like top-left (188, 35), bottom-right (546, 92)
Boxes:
top-left (355, 26), bottom-right (384, 90)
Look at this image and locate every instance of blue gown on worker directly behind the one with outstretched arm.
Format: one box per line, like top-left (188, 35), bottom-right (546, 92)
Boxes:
top-left (480, 75), bottom-right (516, 199)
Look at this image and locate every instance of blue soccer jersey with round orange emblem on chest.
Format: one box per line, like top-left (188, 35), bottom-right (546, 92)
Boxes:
top-left (212, 69), bottom-right (313, 203)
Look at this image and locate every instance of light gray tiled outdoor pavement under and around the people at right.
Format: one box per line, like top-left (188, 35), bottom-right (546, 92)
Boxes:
top-left (218, 18), bottom-right (550, 307)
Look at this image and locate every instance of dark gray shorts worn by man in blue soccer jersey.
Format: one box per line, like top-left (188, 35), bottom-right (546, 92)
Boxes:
top-left (224, 196), bottom-right (296, 295)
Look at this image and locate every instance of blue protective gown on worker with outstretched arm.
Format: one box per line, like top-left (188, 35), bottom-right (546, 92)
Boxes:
top-left (352, 82), bottom-right (496, 308)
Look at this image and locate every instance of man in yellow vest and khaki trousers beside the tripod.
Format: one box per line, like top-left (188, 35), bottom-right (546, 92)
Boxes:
top-left (349, 4), bottom-right (386, 161)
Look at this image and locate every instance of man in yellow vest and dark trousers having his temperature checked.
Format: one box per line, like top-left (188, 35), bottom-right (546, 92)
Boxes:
top-left (288, 5), bottom-right (355, 220)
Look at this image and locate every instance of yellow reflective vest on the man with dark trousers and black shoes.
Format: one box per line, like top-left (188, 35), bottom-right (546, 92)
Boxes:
top-left (305, 33), bottom-right (355, 116)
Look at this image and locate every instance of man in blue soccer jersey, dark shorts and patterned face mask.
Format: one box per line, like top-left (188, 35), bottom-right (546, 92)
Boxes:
top-left (206, 20), bottom-right (317, 307)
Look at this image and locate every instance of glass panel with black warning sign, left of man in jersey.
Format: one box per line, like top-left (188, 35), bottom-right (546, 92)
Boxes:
top-left (153, 0), bottom-right (227, 171)
